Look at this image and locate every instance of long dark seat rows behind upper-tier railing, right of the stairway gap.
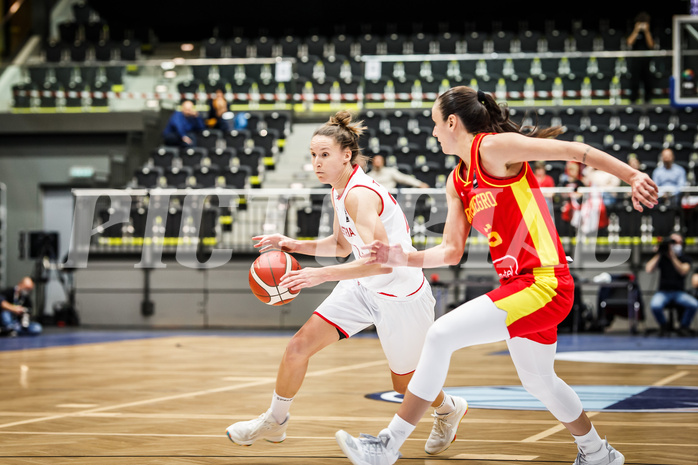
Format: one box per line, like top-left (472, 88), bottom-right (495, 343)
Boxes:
top-left (177, 52), bottom-right (671, 106)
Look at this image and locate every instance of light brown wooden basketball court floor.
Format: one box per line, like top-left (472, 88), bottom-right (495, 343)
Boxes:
top-left (0, 331), bottom-right (698, 465)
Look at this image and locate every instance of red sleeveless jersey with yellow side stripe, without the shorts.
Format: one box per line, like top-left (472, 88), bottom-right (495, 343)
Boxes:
top-left (453, 133), bottom-right (567, 282)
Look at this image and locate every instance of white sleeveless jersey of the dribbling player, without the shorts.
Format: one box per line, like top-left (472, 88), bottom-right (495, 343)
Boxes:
top-left (332, 165), bottom-right (424, 297)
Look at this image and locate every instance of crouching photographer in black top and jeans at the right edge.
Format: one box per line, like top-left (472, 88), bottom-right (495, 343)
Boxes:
top-left (645, 233), bottom-right (698, 336)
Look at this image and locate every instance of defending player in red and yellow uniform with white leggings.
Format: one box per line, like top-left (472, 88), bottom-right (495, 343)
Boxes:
top-left (336, 86), bottom-right (657, 465)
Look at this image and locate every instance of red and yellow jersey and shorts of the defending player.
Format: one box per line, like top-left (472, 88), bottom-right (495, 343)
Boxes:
top-left (453, 133), bottom-right (574, 344)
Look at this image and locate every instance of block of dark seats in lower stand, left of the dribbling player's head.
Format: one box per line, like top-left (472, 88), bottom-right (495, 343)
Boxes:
top-left (130, 112), bottom-right (292, 189)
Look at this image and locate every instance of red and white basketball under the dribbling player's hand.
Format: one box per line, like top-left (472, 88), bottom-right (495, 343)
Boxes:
top-left (249, 250), bottom-right (301, 305)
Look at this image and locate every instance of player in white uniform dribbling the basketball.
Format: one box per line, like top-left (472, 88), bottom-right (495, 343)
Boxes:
top-left (226, 111), bottom-right (468, 454)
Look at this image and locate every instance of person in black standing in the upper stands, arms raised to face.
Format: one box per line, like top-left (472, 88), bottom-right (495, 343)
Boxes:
top-left (625, 11), bottom-right (654, 103)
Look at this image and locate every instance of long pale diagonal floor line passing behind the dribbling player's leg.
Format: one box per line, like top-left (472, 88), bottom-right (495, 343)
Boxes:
top-left (0, 360), bottom-right (388, 428)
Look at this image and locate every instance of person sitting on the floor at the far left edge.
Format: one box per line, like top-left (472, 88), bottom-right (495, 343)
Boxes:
top-left (0, 276), bottom-right (42, 336)
